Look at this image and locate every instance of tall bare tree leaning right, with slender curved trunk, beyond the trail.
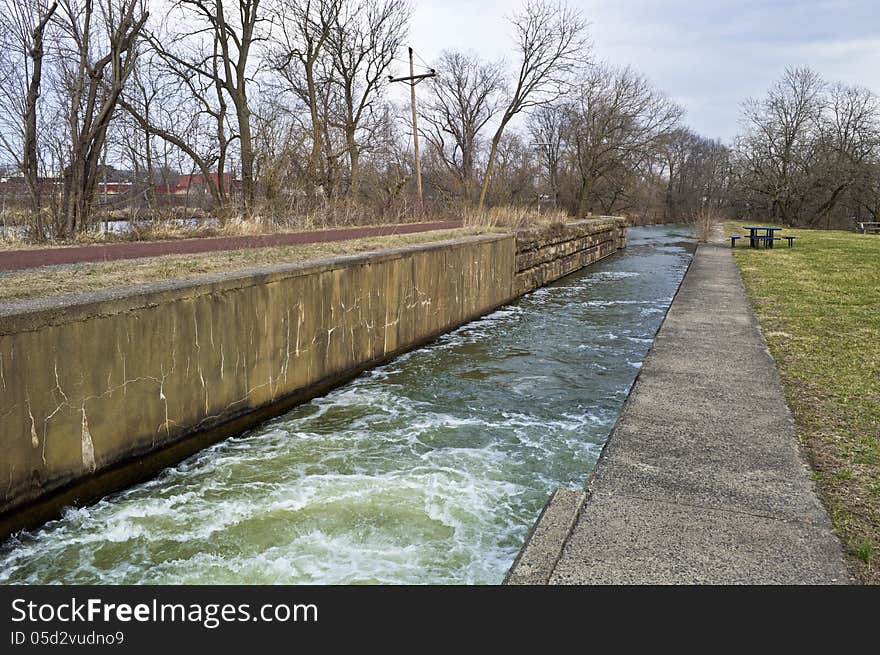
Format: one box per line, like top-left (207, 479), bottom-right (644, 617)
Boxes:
top-left (477, 0), bottom-right (588, 211)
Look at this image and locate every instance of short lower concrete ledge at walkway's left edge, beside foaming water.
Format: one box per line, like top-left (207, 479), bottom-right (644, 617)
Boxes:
top-left (504, 489), bottom-right (586, 585)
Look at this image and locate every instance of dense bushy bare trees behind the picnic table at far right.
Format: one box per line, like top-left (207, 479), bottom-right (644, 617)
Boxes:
top-left (731, 68), bottom-right (880, 227)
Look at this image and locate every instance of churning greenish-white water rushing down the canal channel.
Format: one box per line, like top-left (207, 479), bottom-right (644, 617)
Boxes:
top-left (0, 226), bottom-right (690, 584)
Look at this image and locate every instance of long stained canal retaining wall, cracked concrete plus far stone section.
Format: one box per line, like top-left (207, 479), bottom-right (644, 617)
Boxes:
top-left (0, 221), bottom-right (625, 536)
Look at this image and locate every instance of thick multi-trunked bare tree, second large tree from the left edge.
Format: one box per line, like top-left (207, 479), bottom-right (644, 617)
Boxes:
top-left (58, 0), bottom-right (149, 234)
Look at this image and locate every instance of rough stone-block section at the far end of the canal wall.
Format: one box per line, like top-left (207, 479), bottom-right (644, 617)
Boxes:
top-left (515, 217), bottom-right (626, 295)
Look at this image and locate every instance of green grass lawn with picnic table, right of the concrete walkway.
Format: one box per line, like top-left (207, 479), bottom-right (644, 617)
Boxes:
top-left (727, 223), bottom-right (880, 584)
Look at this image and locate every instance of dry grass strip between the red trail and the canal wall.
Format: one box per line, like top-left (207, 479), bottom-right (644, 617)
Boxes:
top-left (0, 227), bottom-right (488, 302)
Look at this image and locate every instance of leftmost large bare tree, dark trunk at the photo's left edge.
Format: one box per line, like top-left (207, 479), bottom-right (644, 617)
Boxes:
top-left (0, 0), bottom-right (58, 239)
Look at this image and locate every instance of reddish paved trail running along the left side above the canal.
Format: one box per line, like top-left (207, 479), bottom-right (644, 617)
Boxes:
top-left (0, 221), bottom-right (462, 271)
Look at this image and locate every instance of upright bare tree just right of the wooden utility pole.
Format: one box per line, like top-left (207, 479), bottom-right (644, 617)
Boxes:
top-left (422, 51), bottom-right (504, 200)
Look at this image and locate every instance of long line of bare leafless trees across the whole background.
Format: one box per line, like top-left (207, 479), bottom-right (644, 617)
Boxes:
top-left (0, 0), bottom-right (877, 238)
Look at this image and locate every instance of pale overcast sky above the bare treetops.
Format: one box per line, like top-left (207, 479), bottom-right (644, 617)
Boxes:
top-left (401, 0), bottom-right (880, 141)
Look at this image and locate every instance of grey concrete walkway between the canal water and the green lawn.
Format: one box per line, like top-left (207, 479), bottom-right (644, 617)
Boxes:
top-left (507, 244), bottom-right (849, 584)
